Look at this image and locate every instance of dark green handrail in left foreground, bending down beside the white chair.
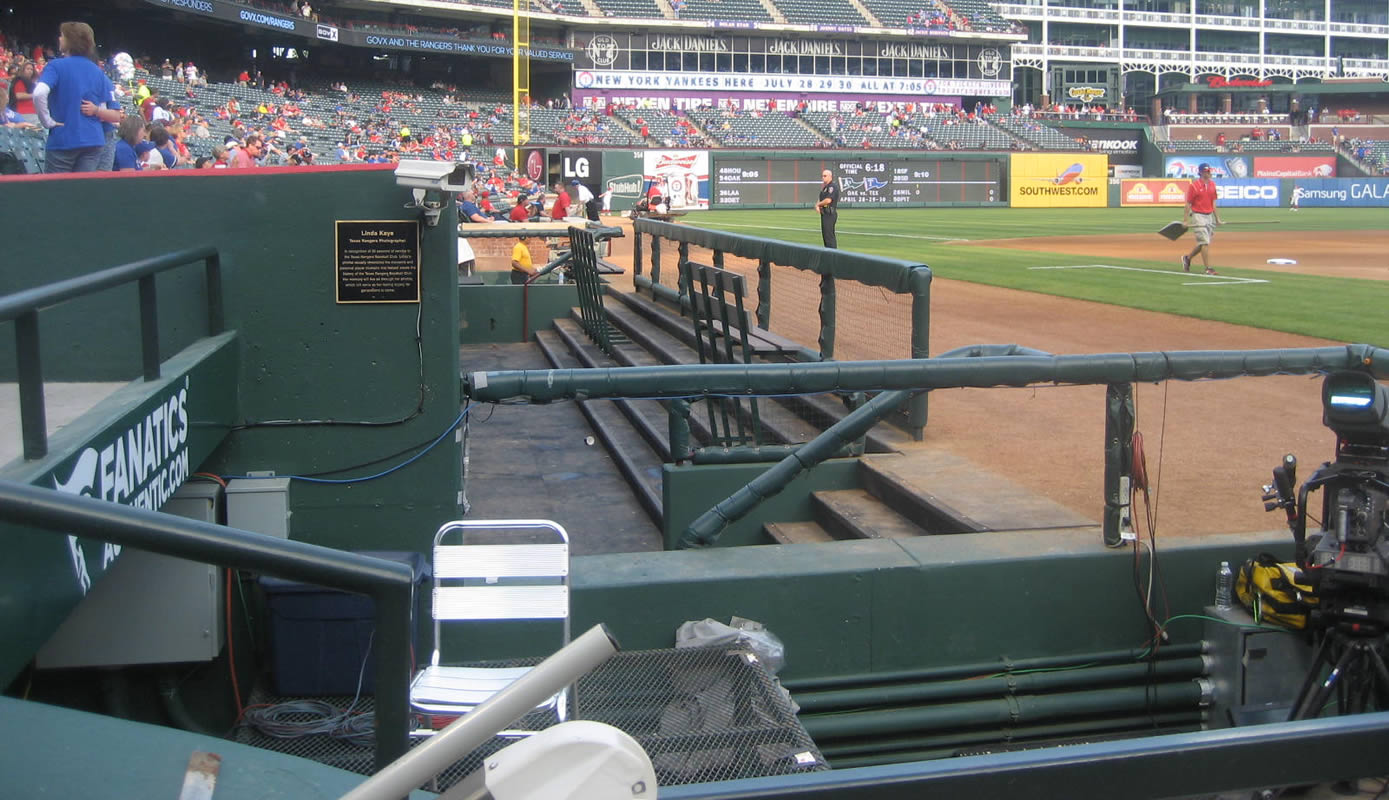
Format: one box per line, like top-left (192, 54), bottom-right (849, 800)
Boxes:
top-left (0, 481), bottom-right (415, 769)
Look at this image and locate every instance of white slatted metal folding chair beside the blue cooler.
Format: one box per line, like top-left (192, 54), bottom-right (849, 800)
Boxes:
top-left (410, 519), bottom-right (569, 736)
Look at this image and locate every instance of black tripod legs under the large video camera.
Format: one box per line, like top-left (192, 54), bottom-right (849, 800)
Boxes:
top-left (1288, 622), bottom-right (1389, 721)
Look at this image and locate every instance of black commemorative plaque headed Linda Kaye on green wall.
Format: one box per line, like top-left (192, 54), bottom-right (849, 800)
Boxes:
top-left (336, 219), bottom-right (419, 303)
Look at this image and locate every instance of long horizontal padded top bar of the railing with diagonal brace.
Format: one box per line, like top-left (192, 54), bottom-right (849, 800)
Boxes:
top-left (465, 344), bottom-right (1389, 403)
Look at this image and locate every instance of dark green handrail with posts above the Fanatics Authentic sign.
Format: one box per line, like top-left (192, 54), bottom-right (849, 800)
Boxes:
top-left (0, 246), bottom-right (226, 461)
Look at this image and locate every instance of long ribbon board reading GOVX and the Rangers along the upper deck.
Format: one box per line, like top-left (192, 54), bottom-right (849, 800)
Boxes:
top-left (144, 0), bottom-right (574, 63)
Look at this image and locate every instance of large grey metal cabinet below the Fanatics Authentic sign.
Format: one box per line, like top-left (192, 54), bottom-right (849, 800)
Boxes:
top-left (35, 482), bottom-right (225, 669)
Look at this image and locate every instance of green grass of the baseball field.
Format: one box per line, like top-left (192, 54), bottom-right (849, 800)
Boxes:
top-left (685, 208), bottom-right (1389, 346)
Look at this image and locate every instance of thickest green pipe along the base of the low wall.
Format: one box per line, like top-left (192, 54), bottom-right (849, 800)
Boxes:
top-left (801, 681), bottom-right (1201, 742)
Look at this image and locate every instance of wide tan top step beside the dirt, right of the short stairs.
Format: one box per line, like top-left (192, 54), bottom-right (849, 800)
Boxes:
top-left (860, 450), bottom-right (1096, 533)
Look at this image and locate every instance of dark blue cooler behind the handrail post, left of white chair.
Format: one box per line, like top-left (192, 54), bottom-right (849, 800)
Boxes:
top-left (260, 550), bottom-right (429, 697)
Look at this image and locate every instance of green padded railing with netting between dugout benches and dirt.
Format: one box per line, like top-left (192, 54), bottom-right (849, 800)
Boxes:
top-left (632, 219), bottom-right (931, 442)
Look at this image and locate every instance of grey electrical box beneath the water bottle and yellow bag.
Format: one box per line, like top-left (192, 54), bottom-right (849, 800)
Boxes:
top-left (1204, 606), bottom-right (1313, 728)
